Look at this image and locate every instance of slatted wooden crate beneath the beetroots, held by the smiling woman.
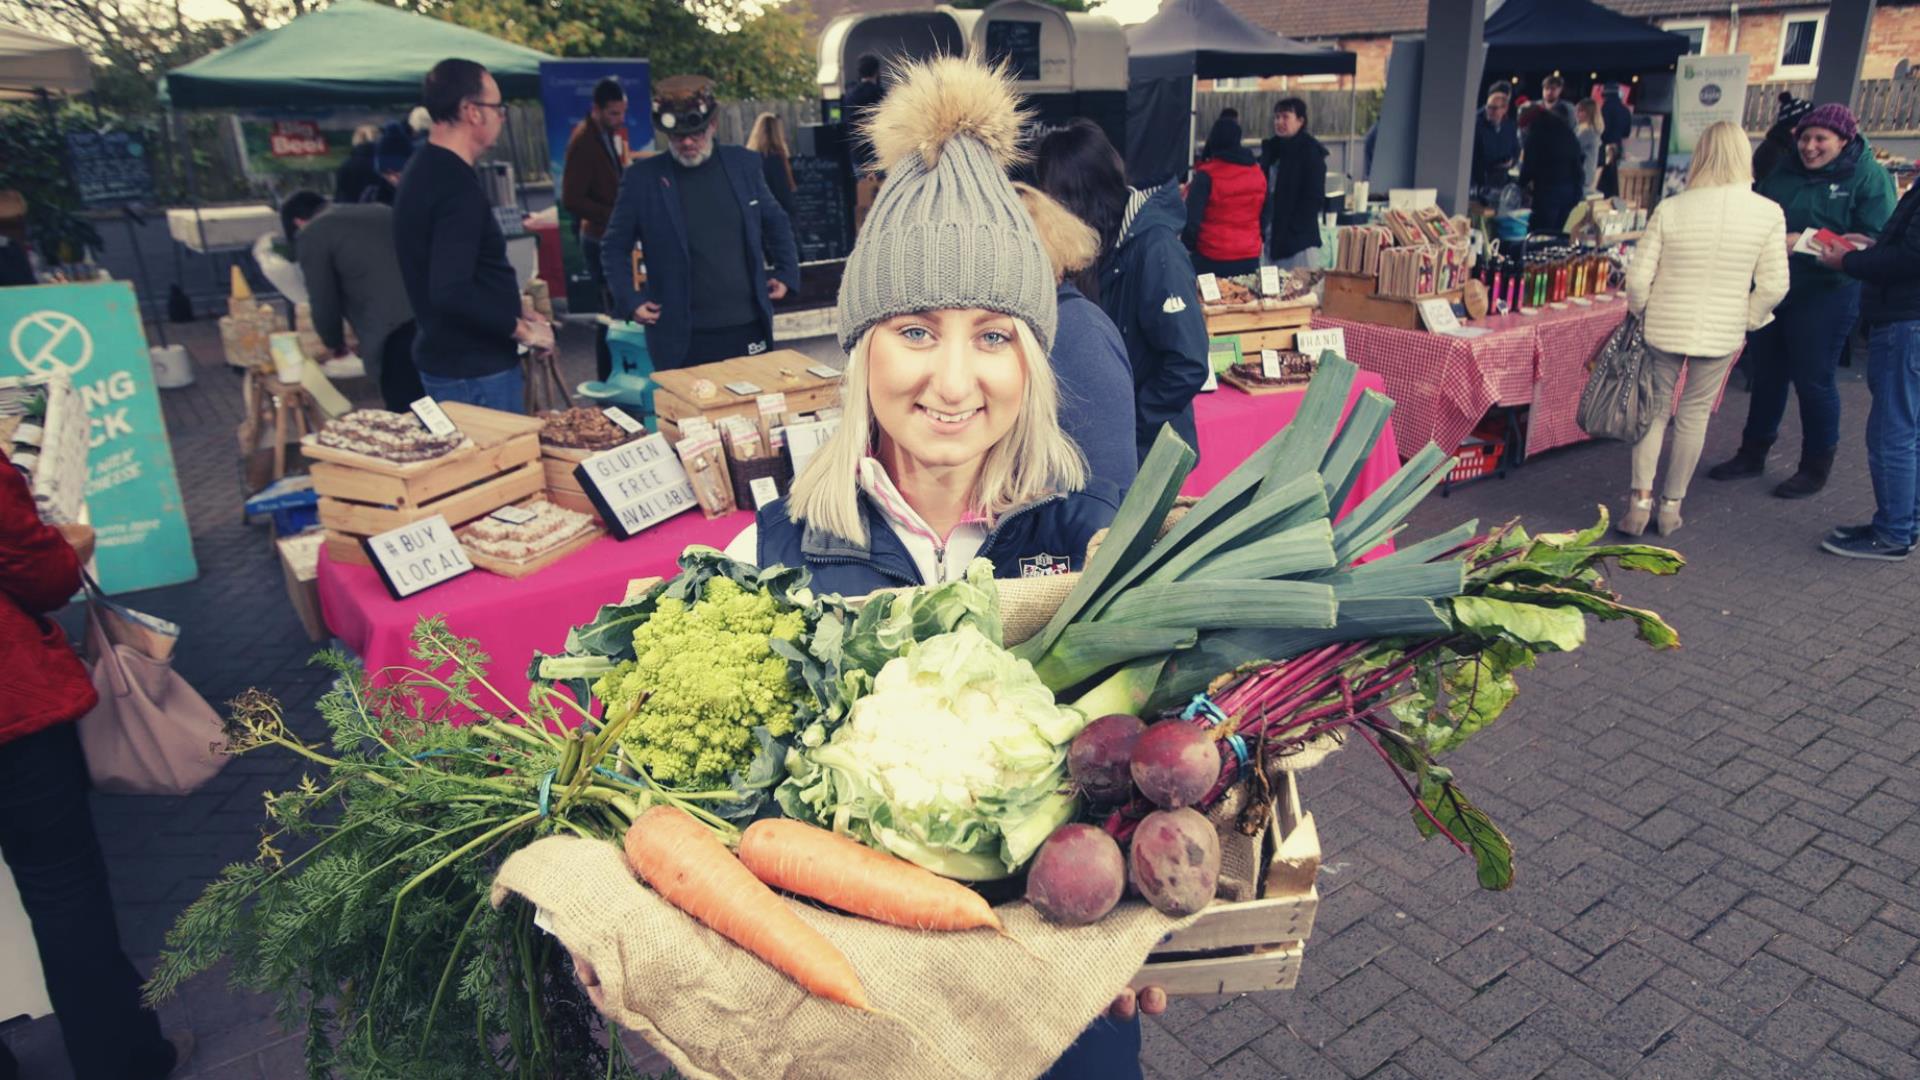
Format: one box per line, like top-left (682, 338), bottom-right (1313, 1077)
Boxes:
top-left (1133, 773), bottom-right (1321, 994)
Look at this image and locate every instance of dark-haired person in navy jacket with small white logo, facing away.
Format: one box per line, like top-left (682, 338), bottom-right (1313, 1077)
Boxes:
top-left (1035, 119), bottom-right (1208, 461)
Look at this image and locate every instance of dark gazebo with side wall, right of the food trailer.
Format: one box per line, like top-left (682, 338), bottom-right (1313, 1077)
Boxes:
top-left (1127, 0), bottom-right (1354, 184)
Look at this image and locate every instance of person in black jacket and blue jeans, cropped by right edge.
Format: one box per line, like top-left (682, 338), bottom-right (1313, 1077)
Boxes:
top-left (1820, 184), bottom-right (1920, 561)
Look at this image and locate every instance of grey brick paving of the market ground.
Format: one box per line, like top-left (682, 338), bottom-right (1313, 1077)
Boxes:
top-left (8, 315), bottom-right (1920, 1080)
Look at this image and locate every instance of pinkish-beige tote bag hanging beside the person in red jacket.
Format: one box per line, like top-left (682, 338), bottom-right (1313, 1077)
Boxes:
top-left (79, 577), bottom-right (227, 796)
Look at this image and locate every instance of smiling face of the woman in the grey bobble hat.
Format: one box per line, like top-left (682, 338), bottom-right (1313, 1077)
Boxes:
top-left (866, 307), bottom-right (1027, 469)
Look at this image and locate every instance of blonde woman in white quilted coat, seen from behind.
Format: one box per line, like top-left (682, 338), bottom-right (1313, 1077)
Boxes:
top-left (1619, 121), bottom-right (1788, 536)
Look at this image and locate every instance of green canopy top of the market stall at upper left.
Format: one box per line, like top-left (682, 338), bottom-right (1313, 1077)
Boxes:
top-left (161, 0), bottom-right (553, 110)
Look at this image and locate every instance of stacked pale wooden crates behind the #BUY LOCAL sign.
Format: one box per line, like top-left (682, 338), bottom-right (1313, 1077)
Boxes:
top-left (301, 402), bottom-right (545, 565)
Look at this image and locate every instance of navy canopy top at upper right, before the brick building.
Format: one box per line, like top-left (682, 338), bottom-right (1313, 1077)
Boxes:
top-left (1486, 0), bottom-right (1688, 75)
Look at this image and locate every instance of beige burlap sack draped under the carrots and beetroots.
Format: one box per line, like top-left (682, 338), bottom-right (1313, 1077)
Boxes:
top-left (493, 836), bottom-right (1190, 1080)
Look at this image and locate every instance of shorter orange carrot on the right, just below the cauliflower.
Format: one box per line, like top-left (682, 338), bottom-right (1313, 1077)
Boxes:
top-left (739, 819), bottom-right (1000, 930)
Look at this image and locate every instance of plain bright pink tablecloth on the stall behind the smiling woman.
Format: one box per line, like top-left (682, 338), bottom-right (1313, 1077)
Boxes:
top-left (319, 373), bottom-right (1400, 703)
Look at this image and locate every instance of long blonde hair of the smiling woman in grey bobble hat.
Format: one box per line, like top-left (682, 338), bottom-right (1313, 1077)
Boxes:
top-left (787, 319), bottom-right (1087, 544)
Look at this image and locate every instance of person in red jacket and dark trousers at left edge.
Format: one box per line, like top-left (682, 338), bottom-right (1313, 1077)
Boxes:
top-left (0, 454), bottom-right (194, 1080)
